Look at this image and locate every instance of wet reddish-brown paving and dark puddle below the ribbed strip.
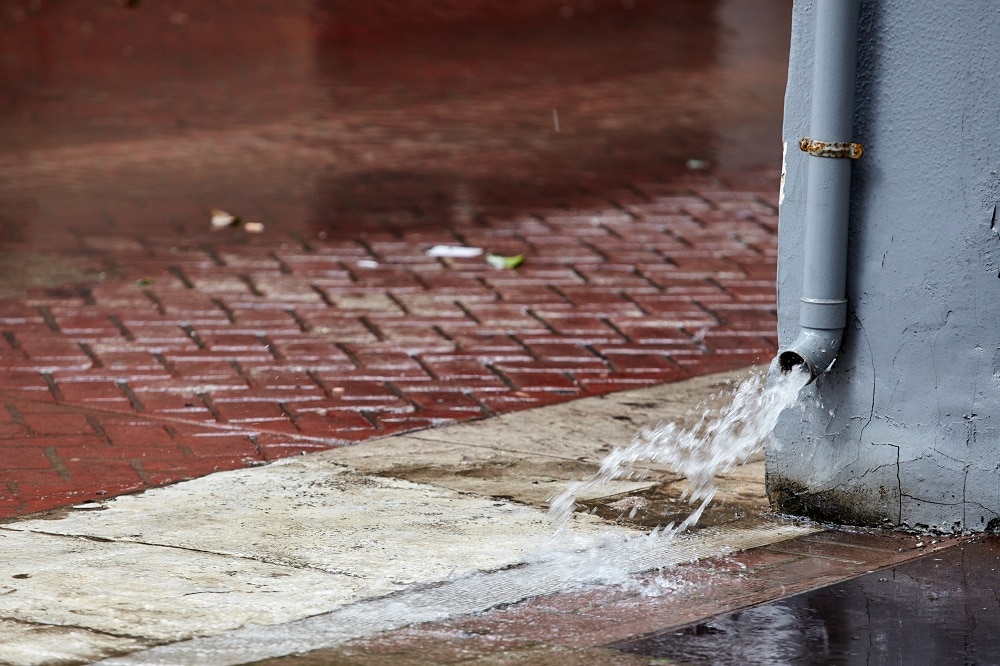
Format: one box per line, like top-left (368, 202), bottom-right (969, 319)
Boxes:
top-left (242, 531), bottom-right (968, 666)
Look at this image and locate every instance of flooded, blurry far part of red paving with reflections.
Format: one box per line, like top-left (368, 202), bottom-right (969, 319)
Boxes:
top-left (0, 0), bottom-right (790, 240)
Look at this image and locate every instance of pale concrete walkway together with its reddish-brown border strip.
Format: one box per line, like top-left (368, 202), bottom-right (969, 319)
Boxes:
top-left (0, 372), bottom-right (961, 666)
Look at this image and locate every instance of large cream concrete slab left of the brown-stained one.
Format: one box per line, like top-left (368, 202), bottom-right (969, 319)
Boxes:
top-left (5, 457), bottom-right (616, 580)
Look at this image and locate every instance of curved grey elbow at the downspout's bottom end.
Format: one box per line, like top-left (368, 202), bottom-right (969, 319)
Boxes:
top-left (778, 298), bottom-right (847, 381)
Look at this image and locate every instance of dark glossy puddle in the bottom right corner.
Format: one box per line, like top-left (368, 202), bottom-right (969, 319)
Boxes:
top-left (615, 537), bottom-right (1000, 664)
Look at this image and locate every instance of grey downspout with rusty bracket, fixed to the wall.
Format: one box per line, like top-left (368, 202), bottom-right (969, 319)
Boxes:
top-left (778, 0), bottom-right (862, 379)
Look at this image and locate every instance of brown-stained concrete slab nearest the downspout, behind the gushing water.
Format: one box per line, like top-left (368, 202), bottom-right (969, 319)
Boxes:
top-left (318, 369), bottom-right (766, 509)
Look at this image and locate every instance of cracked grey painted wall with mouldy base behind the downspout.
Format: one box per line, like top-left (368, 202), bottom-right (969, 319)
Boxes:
top-left (767, 0), bottom-right (1000, 532)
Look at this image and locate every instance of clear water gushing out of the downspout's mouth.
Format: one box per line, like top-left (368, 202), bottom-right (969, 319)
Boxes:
top-left (549, 371), bottom-right (809, 535)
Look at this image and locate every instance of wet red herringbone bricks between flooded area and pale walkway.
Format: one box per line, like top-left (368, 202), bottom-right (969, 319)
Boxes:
top-left (0, 177), bottom-right (776, 516)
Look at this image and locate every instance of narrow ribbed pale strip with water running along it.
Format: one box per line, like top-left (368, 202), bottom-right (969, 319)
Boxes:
top-left (94, 524), bottom-right (817, 666)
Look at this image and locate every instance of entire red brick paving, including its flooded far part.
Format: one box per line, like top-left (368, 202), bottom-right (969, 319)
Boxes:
top-left (0, 0), bottom-right (789, 517)
